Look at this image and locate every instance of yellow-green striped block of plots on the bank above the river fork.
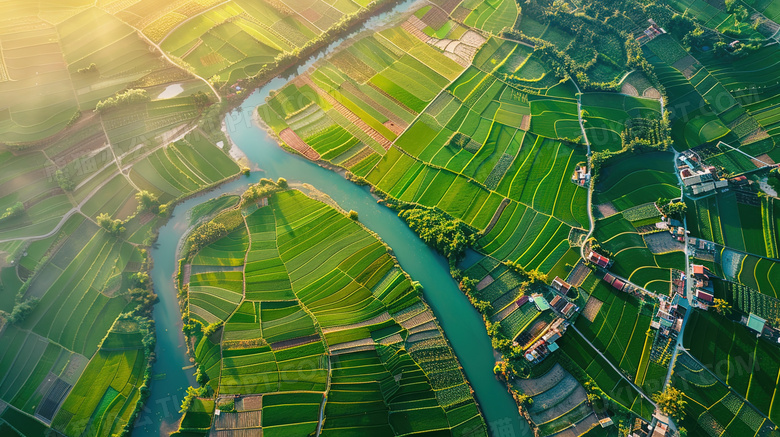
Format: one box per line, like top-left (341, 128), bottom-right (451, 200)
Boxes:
top-left (259, 19), bottom-right (472, 176)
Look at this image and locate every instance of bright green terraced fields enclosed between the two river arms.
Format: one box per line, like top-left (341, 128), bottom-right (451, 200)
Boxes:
top-left (183, 191), bottom-right (486, 435)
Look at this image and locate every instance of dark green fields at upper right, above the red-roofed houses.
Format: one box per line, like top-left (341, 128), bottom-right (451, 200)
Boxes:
top-left (644, 31), bottom-right (777, 169)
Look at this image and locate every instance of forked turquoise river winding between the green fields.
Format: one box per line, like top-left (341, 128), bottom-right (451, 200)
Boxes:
top-left (133, 0), bottom-right (531, 437)
